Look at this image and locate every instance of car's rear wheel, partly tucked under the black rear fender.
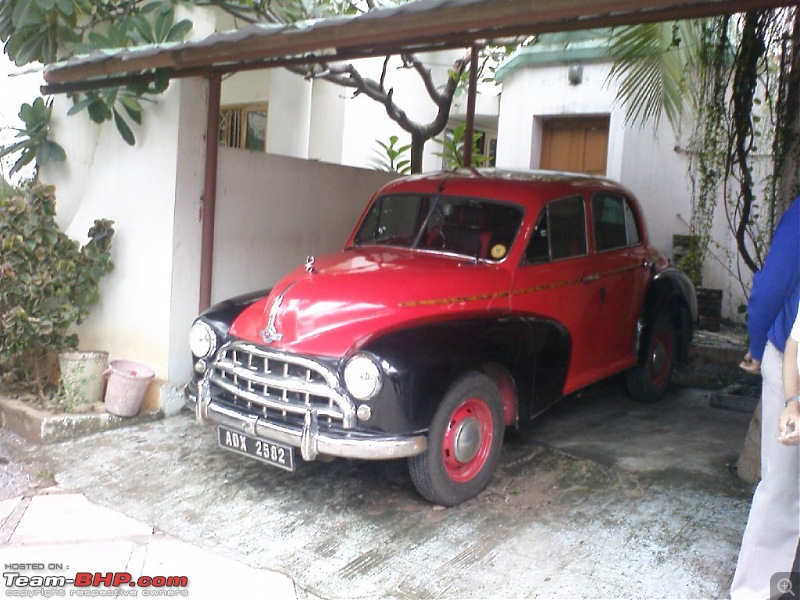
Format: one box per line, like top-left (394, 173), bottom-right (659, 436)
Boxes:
top-left (626, 313), bottom-right (676, 403)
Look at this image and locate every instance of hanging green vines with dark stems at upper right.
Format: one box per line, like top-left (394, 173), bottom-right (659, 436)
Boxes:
top-left (682, 9), bottom-right (800, 291)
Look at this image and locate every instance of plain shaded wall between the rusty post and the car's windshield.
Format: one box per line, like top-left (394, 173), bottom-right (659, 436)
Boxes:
top-left (212, 148), bottom-right (393, 302)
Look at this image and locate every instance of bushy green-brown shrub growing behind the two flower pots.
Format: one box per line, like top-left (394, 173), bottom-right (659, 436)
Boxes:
top-left (0, 186), bottom-right (114, 398)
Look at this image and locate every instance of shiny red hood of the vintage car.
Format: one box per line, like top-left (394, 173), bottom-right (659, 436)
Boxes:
top-left (230, 248), bottom-right (510, 357)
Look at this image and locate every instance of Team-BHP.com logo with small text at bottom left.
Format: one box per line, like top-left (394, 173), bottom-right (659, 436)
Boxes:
top-left (3, 565), bottom-right (189, 598)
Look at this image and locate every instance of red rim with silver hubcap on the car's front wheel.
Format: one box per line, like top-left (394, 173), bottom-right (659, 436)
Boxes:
top-left (442, 398), bottom-right (494, 483)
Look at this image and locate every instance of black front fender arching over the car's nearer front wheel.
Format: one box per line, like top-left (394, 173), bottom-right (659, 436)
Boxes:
top-left (341, 314), bottom-right (571, 433)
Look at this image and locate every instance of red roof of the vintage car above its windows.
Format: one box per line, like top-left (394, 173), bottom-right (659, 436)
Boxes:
top-left (379, 168), bottom-right (633, 212)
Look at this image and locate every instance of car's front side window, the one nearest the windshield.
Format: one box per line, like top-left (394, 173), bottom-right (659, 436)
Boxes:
top-left (525, 196), bottom-right (586, 263)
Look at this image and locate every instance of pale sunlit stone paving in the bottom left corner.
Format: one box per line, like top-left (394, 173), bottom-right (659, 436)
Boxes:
top-left (0, 493), bottom-right (305, 600)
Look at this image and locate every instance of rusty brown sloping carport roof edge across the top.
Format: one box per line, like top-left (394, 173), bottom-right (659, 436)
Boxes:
top-left (44, 0), bottom-right (794, 92)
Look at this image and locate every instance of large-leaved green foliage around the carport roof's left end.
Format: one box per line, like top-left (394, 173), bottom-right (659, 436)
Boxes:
top-left (0, 0), bottom-right (192, 159)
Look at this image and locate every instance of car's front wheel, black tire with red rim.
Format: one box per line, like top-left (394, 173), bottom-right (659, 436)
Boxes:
top-left (408, 372), bottom-right (505, 506)
